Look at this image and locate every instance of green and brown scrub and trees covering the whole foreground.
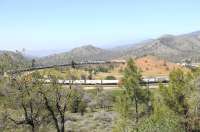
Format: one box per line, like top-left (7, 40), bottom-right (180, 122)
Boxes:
top-left (0, 58), bottom-right (200, 132)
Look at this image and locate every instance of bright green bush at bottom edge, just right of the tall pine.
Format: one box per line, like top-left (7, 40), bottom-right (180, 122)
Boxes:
top-left (139, 97), bottom-right (184, 132)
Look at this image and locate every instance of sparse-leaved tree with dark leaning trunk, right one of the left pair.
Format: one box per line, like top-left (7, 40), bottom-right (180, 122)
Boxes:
top-left (38, 76), bottom-right (71, 132)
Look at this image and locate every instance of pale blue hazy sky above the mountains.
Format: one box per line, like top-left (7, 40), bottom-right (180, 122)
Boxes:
top-left (0, 0), bottom-right (200, 50)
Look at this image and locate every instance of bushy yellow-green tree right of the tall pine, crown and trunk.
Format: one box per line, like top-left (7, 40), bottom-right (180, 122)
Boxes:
top-left (160, 69), bottom-right (193, 132)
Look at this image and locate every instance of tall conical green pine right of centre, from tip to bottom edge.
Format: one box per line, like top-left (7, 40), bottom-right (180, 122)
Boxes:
top-left (114, 59), bottom-right (149, 132)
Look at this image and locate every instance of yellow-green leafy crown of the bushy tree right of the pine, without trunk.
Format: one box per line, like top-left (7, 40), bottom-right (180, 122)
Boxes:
top-left (160, 69), bottom-right (192, 114)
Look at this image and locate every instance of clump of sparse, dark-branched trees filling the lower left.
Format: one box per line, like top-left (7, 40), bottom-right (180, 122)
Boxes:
top-left (0, 72), bottom-right (87, 132)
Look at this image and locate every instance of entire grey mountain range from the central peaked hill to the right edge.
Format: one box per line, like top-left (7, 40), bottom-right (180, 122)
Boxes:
top-left (1, 31), bottom-right (200, 65)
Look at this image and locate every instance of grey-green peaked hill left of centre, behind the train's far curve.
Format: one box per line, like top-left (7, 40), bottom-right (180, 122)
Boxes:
top-left (37, 45), bottom-right (116, 65)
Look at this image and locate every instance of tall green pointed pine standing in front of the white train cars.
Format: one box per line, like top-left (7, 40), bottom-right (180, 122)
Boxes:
top-left (114, 59), bottom-right (148, 131)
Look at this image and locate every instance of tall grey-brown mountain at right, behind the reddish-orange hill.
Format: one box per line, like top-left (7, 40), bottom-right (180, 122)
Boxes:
top-left (115, 32), bottom-right (200, 62)
